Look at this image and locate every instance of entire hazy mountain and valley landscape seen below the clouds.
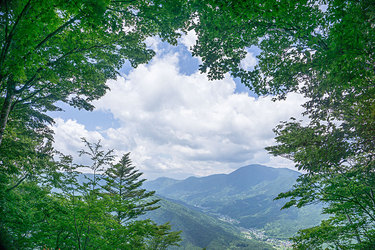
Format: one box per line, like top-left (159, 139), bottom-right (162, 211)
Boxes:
top-left (144, 165), bottom-right (324, 249)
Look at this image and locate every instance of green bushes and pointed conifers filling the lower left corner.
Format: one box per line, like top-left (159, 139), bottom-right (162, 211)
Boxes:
top-left (1, 140), bottom-right (180, 249)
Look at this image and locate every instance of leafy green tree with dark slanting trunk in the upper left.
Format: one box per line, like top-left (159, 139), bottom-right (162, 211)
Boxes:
top-left (0, 0), bottom-right (189, 145)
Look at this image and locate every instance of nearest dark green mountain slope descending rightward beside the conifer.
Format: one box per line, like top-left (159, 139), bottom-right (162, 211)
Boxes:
top-left (143, 199), bottom-right (273, 250)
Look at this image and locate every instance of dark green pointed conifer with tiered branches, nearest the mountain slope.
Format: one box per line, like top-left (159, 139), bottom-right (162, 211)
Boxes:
top-left (101, 150), bottom-right (181, 249)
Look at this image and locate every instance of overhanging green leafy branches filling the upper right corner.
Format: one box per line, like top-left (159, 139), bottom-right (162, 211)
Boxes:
top-left (190, 0), bottom-right (374, 98)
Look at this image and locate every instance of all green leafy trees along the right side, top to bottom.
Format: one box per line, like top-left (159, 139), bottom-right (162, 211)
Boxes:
top-left (190, 0), bottom-right (375, 249)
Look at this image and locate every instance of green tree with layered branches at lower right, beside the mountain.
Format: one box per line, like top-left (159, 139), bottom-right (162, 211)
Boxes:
top-left (269, 119), bottom-right (375, 249)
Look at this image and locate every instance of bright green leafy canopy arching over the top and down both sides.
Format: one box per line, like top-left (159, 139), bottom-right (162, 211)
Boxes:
top-left (0, 0), bottom-right (375, 249)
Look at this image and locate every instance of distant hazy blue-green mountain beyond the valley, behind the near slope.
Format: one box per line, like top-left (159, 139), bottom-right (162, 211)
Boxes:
top-left (144, 165), bottom-right (323, 239)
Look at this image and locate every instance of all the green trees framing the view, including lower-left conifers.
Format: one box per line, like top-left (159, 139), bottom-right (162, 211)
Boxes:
top-left (0, 0), bottom-right (375, 249)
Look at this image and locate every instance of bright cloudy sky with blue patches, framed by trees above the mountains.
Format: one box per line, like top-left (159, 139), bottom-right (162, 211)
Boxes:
top-left (50, 32), bottom-right (305, 180)
